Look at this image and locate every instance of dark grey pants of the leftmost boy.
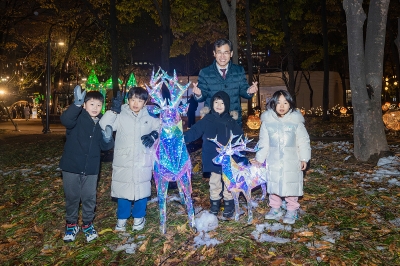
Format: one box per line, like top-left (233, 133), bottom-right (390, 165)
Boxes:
top-left (62, 171), bottom-right (98, 224)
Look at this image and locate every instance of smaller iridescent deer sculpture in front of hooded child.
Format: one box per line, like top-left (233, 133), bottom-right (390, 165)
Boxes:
top-left (209, 132), bottom-right (267, 223)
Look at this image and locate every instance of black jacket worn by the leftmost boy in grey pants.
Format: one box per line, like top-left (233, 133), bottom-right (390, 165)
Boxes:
top-left (60, 104), bottom-right (114, 175)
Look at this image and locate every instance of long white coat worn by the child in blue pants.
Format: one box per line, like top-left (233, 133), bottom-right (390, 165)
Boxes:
top-left (100, 104), bottom-right (160, 200)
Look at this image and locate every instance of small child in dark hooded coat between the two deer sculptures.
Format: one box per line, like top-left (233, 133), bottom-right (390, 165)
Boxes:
top-left (184, 91), bottom-right (243, 218)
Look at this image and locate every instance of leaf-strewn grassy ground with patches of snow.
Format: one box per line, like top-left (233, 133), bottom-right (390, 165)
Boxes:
top-left (0, 118), bottom-right (400, 265)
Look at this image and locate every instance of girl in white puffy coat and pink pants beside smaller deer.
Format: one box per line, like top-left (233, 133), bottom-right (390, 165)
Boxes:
top-left (252, 90), bottom-right (311, 224)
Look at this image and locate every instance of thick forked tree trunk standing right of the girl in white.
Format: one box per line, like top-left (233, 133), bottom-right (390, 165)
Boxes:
top-left (343, 0), bottom-right (389, 161)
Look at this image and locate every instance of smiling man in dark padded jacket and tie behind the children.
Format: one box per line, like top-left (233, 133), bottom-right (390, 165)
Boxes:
top-left (193, 39), bottom-right (258, 125)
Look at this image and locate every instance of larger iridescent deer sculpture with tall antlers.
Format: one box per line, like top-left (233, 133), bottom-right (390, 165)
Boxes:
top-left (146, 70), bottom-right (195, 234)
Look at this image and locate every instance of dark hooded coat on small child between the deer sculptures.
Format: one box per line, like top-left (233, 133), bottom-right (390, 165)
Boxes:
top-left (184, 91), bottom-right (243, 174)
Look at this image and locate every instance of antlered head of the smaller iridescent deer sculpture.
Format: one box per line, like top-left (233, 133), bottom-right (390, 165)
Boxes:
top-left (208, 131), bottom-right (260, 165)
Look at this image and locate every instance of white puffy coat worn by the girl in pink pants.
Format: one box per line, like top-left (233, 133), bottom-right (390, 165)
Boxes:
top-left (256, 109), bottom-right (311, 197)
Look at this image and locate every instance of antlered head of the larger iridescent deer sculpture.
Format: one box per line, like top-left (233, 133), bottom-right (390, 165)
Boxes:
top-left (146, 68), bottom-right (190, 126)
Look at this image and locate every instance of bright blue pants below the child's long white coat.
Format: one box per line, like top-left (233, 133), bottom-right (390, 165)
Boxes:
top-left (117, 198), bottom-right (147, 219)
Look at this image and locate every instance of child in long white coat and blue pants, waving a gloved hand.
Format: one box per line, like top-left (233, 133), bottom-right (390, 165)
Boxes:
top-left (100, 87), bottom-right (160, 231)
